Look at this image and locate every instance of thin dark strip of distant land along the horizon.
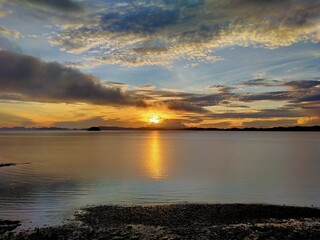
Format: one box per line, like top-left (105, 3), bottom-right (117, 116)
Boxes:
top-left (0, 126), bottom-right (320, 132)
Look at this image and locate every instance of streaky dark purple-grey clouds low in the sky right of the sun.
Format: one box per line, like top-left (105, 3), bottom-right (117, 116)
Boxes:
top-left (180, 79), bottom-right (320, 119)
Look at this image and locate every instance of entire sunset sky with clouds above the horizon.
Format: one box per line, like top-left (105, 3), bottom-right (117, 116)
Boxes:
top-left (0, 0), bottom-right (320, 128)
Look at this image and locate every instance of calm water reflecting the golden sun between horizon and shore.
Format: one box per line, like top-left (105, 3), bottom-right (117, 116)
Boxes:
top-left (0, 131), bottom-right (320, 227)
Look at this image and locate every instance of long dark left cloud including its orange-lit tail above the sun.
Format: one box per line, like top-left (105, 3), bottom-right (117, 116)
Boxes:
top-left (0, 51), bottom-right (212, 113)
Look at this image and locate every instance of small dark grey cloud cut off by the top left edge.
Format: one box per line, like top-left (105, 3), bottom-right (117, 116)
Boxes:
top-left (19, 0), bottom-right (82, 11)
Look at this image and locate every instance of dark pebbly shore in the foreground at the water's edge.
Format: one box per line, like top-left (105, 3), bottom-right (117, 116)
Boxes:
top-left (4, 204), bottom-right (320, 240)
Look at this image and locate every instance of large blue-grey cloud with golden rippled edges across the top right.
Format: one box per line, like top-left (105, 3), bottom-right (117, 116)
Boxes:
top-left (51, 0), bottom-right (320, 66)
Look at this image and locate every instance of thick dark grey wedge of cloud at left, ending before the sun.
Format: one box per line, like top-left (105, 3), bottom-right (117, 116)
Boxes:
top-left (0, 51), bottom-right (146, 107)
